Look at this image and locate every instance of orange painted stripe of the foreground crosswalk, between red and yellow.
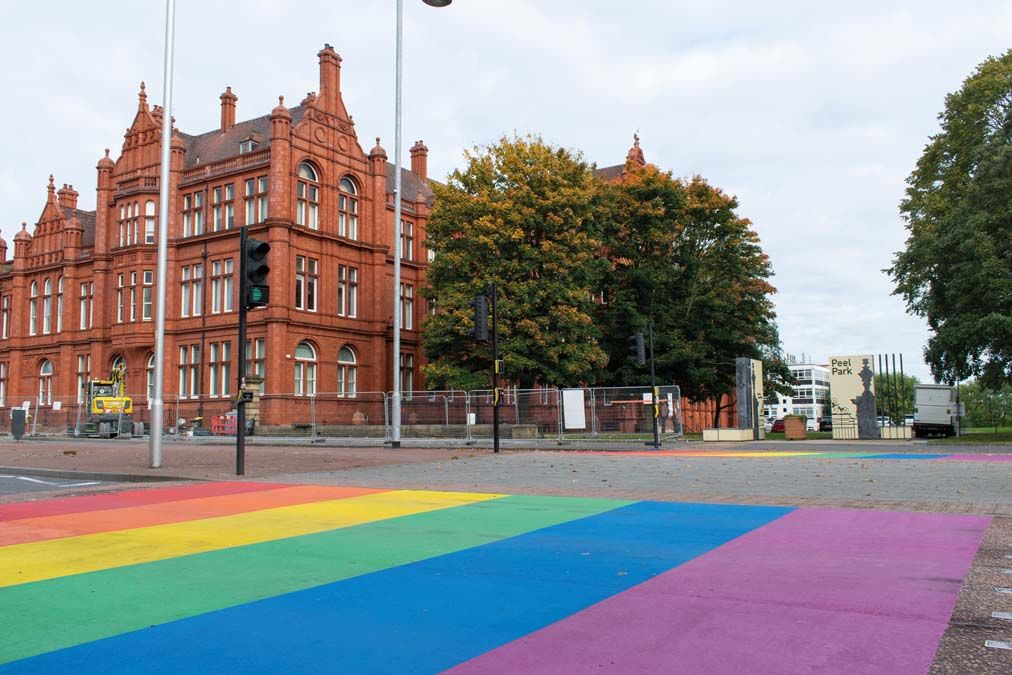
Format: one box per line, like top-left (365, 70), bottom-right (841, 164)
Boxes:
top-left (0, 486), bottom-right (388, 546)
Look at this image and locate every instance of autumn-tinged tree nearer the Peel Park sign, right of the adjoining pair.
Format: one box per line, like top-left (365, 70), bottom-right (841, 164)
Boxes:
top-left (598, 162), bottom-right (790, 423)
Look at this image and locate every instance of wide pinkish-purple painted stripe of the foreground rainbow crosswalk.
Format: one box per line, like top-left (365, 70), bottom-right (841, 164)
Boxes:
top-left (450, 510), bottom-right (990, 675)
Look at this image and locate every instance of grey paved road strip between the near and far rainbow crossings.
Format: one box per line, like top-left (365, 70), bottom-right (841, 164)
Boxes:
top-left (269, 451), bottom-right (1012, 512)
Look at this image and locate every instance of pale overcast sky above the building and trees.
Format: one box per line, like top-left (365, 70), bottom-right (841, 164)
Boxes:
top-left (0, 0), bottom-right (1012, 378)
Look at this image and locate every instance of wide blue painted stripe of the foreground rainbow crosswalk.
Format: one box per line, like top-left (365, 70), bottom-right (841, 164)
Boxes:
top-left (0, 502), bottom-right (791, 675)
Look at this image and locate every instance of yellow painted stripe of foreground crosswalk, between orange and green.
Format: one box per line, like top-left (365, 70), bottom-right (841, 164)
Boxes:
top-left (0, 490), bottom-right (504, 587)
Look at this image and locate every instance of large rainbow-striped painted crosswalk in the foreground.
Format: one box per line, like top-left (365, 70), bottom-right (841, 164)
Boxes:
top-left (0, 483), bottom-right (989, 675)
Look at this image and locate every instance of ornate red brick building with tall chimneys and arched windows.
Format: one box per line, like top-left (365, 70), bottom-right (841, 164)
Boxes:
top-left (0, 45), bottom-right (432, 427)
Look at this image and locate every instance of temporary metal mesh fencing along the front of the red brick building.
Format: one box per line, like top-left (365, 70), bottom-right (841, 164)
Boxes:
top-left (0, 387), bottom-right (682, 442)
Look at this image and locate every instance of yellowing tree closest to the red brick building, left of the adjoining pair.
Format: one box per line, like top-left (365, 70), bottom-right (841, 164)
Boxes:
top-left (424, 136), bottom-right (607, 389)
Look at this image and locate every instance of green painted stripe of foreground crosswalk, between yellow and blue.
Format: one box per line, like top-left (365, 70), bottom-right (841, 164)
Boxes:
top-left (0, 495), bottom-right (633, 663)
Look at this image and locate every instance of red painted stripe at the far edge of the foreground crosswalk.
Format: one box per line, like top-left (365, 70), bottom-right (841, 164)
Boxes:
top-left (0, 481), bottom-right (291, 521)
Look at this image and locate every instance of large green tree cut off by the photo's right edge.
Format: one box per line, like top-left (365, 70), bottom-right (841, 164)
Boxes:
top-left (888, 51), bottom-right (1012, 388)
